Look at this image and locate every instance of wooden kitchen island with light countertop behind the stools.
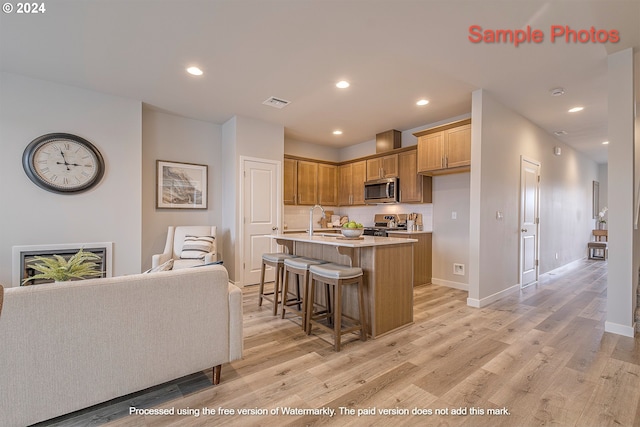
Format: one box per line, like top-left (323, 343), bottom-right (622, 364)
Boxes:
top-left (271, 233), bottom-right (417, 338)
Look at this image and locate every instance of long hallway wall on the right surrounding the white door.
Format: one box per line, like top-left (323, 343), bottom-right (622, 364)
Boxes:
top-left (469, 90), bottom-right (598, 305)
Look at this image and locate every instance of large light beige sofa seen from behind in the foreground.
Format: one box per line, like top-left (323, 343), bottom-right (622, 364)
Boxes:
top-left (0, 265), bottom-right (242, 427)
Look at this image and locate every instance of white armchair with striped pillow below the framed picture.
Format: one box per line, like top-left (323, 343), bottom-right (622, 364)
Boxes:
top-left (151, 225), bottom-right (218, 270)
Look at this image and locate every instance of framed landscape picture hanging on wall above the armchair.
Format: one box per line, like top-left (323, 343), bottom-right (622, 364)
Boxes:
top-left (156, 160), bottom-right (208, 209)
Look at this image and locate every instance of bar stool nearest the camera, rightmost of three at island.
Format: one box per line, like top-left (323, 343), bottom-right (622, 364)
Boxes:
top-left (307, 264), bottom-right (367, 351)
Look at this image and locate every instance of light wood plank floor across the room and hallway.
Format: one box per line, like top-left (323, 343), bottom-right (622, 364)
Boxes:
top-left (37, 260), bottom-right (640, 427)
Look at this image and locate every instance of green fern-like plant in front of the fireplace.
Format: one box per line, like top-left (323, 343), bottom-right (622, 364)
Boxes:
top-left (22, 249), bottom-right (102, 286)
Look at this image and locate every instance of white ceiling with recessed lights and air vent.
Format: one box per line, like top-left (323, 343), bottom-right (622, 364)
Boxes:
top-left (0, 0), bottom-right (640, 163)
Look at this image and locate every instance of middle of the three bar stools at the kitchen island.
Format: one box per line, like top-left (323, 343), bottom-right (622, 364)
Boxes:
top-left (282, 257), bottom-right (327, 331)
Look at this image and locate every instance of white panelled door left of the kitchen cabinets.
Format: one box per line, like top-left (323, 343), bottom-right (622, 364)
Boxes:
top-left (242, 159), bottom-right (282, 285)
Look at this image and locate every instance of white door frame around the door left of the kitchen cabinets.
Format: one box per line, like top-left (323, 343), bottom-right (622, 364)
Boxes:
top-left (236, 156), bottom-right (283, 287)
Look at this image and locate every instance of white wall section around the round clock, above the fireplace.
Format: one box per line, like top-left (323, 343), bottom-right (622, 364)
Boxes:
top-left (0, 73), bottom-right (142, 285)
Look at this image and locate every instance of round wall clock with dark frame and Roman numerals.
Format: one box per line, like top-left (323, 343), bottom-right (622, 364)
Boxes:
top-left (22, 133), bottom-right (104, 194)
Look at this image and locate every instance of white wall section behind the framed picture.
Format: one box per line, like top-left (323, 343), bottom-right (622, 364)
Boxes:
top-left (141, 106), bottom-right (225, 270)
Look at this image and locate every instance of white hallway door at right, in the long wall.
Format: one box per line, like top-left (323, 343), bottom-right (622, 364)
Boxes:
top-left (520, 157), bottom-right (540, 287)
